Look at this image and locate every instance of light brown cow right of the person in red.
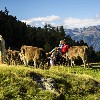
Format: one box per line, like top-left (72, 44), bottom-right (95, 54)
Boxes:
top-left (67, 46), bottom-right (88, 67)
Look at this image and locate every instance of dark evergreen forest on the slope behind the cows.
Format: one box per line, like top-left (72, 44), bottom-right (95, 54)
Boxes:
top-left (0, 7), bottom-right (100, 62)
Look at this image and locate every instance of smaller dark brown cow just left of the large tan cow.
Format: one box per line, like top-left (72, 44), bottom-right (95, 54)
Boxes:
top-left (6, 49), bottom-right (21, 65)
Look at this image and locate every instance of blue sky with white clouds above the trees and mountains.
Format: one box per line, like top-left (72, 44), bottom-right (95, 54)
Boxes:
top-left (0, 0), bottom-right (100, 29)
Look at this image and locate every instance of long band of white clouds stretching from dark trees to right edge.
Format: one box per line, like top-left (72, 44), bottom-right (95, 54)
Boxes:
top-left (22, 14), bottom-right (100, 28)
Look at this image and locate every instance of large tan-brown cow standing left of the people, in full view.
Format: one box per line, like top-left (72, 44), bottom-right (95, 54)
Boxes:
top-left (20, 45), bottom-right (46, 68)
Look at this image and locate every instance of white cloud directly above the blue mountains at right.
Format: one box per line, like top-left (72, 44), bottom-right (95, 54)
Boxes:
top-left (63, 15), bottom-right (100, 28)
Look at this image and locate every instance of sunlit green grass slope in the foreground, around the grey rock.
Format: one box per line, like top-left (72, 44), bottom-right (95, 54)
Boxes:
top-left (0, 65), bottom-right (100, 100)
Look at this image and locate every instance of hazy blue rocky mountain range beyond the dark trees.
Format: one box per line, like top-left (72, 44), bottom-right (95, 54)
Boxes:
top-left (65, 25), bottom-right (100, 51)
